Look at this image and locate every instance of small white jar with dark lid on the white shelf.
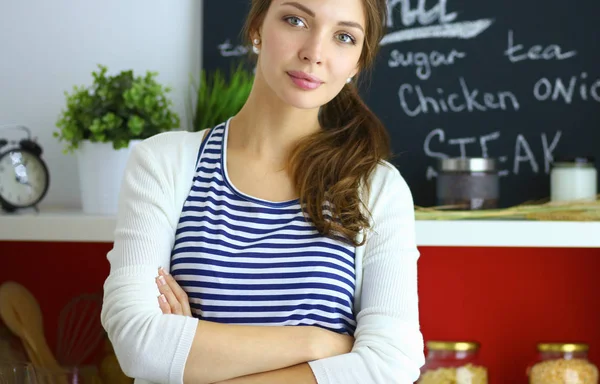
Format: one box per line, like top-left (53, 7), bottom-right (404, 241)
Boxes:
top-left (550, 157), bottom-right (598, 201)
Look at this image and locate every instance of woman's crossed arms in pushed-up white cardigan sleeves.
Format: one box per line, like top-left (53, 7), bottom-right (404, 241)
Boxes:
top-left (101, 140), bottom-right (424, 384)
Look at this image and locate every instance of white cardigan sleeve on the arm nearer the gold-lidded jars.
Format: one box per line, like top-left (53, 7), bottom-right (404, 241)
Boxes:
top-left (309, 163), bottom-right (425, 384)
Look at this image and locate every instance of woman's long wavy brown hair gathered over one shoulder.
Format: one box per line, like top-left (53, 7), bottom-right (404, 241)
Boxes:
top-left (243, 0), bottom-right (390, 246)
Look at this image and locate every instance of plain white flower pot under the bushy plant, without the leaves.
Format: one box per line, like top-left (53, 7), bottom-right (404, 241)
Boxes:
top-left (77, 140), bottom-right (141, 215)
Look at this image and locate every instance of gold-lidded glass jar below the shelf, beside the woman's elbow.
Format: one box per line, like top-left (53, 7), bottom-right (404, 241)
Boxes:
top-left (417, 341), bottom-right (488, 384)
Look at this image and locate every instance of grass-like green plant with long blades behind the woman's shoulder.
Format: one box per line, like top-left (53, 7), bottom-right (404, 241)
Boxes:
top-left (193, 63), bottom-right (254, 131)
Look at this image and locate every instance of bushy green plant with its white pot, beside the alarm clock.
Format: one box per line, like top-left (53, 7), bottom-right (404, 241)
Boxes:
top-left (53, 65), bottom-right (180, 215)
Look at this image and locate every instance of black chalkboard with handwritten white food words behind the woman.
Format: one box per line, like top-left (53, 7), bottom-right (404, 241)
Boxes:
top-left (203, 0), bottom-right (600, 207)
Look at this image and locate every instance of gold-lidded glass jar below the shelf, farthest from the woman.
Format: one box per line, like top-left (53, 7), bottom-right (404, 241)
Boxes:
top-left (527, 343), bottom-right (598, 384)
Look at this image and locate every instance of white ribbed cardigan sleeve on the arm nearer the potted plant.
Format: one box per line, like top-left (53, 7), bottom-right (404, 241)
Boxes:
top-left (101, 139), bottom-right (197, 383)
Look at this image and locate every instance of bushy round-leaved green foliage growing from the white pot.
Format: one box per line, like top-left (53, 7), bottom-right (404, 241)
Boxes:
top-left (53, 65), bottom-right (180, 153)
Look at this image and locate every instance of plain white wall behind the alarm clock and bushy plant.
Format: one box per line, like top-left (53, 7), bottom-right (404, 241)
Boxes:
top-left (0, 0), bottom-right (202, 208)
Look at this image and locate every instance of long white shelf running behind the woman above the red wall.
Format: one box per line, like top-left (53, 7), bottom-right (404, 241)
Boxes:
top-left (0, 209), bottom-right (600, 248)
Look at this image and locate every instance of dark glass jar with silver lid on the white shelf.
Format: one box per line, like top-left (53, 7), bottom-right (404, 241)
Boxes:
top-left (436, 157), bottom-right (500, 210)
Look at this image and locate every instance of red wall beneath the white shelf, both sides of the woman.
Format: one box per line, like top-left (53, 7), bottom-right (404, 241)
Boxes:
top-left (0, 242), bottom-right (600, 384)
